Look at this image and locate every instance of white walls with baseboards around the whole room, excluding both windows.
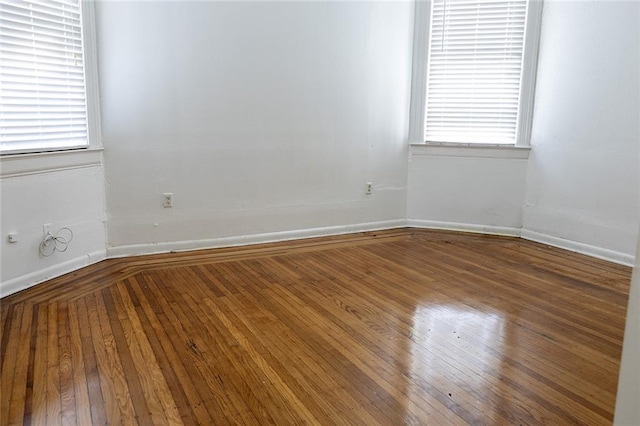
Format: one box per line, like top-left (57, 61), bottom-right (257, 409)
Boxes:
top-left (0, 0), bottom-right (640, 288)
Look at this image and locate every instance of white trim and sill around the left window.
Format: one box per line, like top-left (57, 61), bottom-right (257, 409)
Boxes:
top-left (0, 0), bottom-right (102, 178)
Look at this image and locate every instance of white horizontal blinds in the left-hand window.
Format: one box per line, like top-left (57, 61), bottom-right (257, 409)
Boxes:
top-left (0, 0), bottom-right (87, 153)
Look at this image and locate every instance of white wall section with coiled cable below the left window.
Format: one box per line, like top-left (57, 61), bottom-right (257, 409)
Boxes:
top-left (0, 165), bottom-right (106, 295)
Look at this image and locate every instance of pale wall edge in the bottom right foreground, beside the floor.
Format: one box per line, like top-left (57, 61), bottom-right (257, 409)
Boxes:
top-left (614, 223), bottom-right (640, 426)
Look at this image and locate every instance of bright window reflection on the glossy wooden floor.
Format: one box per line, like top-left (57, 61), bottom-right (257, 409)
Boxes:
top-left (407, 304), bottom-right (505, 422)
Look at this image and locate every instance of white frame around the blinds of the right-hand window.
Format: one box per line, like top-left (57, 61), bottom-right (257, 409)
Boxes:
top-left (409, 0), bottom-right (543, 149)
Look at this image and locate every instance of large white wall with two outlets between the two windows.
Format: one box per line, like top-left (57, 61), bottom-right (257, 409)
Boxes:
top-left (97, 2), bottom-right (413, 248)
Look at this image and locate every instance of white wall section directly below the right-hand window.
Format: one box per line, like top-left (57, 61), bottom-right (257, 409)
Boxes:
top-left (407, 148), bottom-right (527, 232)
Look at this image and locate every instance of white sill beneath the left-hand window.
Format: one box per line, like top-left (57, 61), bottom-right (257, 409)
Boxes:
top-left (0, 148), bottom-right (103, 178)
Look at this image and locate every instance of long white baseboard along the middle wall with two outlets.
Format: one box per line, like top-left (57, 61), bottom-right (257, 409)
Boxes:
top-left (107, 219), bottom-right (407, 258)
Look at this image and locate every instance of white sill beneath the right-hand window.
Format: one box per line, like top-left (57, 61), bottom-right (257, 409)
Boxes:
top-left (410, 143), bottom-right (531, 160)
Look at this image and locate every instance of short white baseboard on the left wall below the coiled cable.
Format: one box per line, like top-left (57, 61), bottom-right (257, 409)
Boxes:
top-left (0, 250), bottom-right (107, 297)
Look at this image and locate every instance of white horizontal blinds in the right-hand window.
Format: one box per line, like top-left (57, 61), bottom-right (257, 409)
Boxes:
top-left (425, 0), bottom-right (527, 144)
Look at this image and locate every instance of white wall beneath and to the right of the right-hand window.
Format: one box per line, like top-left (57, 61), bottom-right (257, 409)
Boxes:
top-left (407, 0), bottom-right (640, 264)
